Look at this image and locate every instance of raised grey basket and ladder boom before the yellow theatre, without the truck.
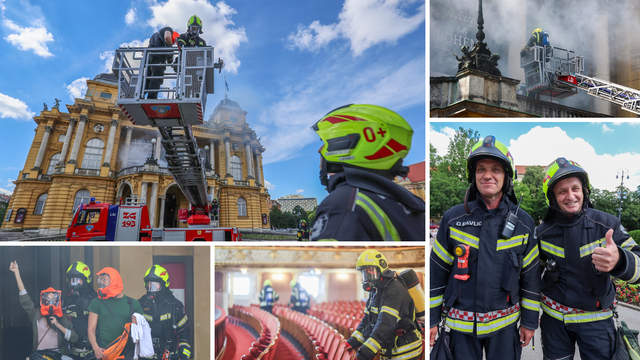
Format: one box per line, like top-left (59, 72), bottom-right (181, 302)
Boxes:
top-left (112, 47), bottom-right (224, 227)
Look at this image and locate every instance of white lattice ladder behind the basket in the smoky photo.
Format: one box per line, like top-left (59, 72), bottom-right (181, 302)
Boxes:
top-left (574, 74), bottom-right (640, 115)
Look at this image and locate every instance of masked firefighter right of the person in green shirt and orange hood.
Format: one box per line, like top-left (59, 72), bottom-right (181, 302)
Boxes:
top-left (139, 265), bottom-right (191, 360)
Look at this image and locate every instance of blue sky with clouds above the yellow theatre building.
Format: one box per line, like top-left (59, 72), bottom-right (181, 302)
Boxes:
top-left (0, 0), bottom-right (426, 202)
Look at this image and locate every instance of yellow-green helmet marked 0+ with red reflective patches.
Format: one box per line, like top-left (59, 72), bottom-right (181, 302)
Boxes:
top-left (311, 105), bottom-right (413, 170)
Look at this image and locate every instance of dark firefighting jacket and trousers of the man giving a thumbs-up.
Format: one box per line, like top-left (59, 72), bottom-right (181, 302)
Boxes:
top-left (537, 208), bottom-right (640, 360)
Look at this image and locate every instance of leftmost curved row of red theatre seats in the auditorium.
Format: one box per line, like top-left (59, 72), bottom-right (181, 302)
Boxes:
top-left (229, 305), bottom-right (280, 360)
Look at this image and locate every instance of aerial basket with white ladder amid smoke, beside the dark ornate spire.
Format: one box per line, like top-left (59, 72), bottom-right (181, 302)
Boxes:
top-left (520, 46), bottom-right (640, 115)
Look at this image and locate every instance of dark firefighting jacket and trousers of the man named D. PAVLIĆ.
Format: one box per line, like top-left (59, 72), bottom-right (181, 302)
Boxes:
top-left (429, 196), bottom-right (541, 360)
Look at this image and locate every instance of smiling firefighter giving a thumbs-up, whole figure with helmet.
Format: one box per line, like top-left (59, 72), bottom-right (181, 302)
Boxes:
top-left (536, 158), bottom-right (640, 360)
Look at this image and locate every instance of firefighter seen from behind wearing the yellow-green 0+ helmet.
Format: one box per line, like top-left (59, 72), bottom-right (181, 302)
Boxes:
top-left (311, 105), bottom-right (425, 241)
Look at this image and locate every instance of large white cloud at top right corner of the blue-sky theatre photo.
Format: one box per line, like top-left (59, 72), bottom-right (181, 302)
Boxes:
top-left (285, 0), bottom-right (425, 56)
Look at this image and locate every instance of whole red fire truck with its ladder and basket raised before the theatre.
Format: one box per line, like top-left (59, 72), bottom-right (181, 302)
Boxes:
top-left (67, 47), bottom-right (241, 241)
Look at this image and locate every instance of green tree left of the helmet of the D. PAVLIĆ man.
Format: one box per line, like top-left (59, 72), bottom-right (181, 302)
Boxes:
top-left (438, 127), bottom-right (480, 183)
